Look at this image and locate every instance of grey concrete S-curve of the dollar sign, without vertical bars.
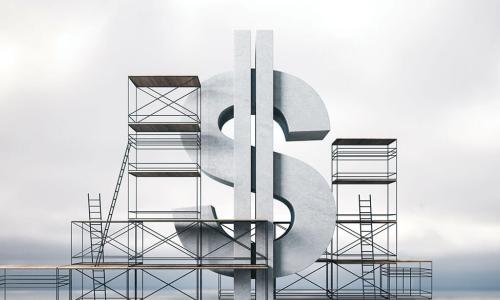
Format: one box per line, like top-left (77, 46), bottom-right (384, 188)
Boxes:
top-left (176, 70), bottom-right (335, 277)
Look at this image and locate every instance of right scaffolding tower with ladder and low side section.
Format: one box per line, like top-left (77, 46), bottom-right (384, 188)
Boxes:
top-left (325, 139), bottom-right (432, 299)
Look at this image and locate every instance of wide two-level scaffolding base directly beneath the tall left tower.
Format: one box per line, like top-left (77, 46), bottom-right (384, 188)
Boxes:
top-left (70, 218), bottom-right (268, 299)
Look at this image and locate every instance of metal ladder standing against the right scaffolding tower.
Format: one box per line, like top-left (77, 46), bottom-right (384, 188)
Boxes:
top-left (358, 194), bottom-right (376, 299)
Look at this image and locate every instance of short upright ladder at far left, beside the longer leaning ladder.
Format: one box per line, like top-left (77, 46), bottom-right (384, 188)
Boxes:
top-left (87, 194), bottom-right (106, 299)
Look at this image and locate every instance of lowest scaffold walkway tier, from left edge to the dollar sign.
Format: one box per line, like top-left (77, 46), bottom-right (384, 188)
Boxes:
top-left (0, 263), bottom-right (268, 300)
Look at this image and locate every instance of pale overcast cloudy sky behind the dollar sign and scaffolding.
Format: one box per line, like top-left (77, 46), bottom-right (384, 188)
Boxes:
top-left (0, 0), bottom-right (500, 289)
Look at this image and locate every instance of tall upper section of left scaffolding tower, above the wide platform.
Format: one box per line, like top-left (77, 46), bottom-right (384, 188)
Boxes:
top-left (127, 76), bottom-right (201, 221)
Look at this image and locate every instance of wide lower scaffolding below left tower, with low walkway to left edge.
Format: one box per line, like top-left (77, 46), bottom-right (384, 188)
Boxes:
top-left (0, 218), bottom-right (269, 300)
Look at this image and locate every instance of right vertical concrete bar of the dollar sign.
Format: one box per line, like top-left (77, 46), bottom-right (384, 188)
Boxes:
top-left (255, 30), bottom-right (274, 300)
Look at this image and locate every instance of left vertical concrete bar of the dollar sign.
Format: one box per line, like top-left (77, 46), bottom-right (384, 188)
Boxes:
top-left (233, 30), bottom-right (252, 300)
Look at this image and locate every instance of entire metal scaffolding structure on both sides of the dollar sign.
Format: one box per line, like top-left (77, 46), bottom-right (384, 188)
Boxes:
top-left (0, 76), bottom-right (432, 299)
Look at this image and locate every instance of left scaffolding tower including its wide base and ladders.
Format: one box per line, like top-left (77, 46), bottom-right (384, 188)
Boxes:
top-left (64, 76), bottom-right (268, 299)
